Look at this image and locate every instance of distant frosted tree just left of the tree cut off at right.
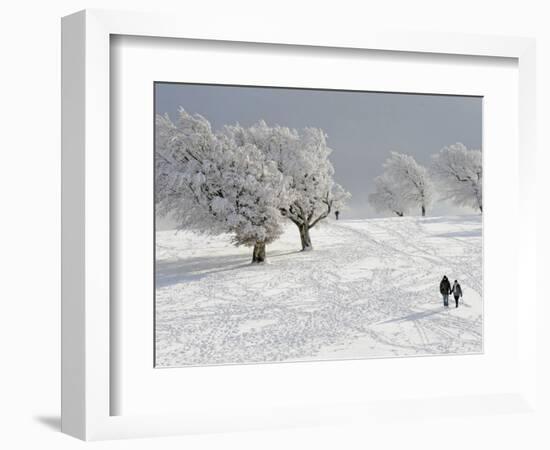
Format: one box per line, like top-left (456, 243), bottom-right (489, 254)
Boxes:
top-left (384, 152), bottom-right (433, 217)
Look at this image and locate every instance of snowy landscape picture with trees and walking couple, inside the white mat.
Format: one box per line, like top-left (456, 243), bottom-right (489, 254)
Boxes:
top-left (154, 82), bottom-right (483, 367)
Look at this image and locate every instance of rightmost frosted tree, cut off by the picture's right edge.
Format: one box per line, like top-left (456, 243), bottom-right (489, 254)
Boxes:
top-left (431, 142), bottom-right (483, 212)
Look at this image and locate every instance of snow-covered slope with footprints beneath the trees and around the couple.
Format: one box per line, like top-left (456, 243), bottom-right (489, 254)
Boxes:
top-left (156, 215), bottom-right (483, 367)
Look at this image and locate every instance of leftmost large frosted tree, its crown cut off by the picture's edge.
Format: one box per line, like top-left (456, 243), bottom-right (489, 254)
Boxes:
top-left (155, 109), bottom-right (287, 262)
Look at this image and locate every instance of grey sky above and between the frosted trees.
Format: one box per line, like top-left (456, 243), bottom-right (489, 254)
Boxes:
top-left (155, 83), bottom-right (482, 218)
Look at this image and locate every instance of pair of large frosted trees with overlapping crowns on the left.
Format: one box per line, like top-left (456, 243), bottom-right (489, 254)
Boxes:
top-left (155, 109), bottom-right (350, 262)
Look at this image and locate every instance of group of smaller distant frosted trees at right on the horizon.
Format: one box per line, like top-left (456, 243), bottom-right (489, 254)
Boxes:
top-left (369, 143), bottom-right (483, 216)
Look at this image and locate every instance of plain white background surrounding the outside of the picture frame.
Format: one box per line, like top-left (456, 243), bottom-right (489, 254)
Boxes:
top-left (0, 0), bottom-right (550, 450)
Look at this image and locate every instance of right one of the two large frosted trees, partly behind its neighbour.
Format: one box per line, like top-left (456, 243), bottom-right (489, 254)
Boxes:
top-left (226, 121), bottom-right (351, 250)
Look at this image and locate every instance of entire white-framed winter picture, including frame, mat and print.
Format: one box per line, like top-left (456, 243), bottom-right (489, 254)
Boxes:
top-left (62, 11), bottom-right (536, 440)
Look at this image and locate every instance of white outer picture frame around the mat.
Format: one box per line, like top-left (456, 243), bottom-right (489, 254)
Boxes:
top-left (62, 10), bottom-right (537, 440)
